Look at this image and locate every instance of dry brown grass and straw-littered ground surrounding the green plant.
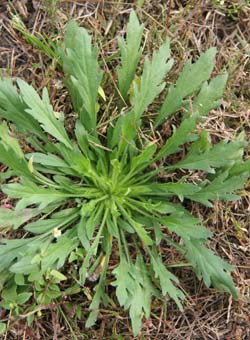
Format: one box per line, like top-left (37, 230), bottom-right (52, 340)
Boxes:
top-left (0, 0), bottom-right (250, 340)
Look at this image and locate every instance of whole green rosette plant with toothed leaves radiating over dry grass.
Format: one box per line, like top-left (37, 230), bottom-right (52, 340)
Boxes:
top-left (0, 12), bottom-right (250, 335)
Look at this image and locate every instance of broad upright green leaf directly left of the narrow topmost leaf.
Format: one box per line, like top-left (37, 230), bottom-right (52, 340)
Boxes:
top-left (61, 20), bottom-right (102, 132)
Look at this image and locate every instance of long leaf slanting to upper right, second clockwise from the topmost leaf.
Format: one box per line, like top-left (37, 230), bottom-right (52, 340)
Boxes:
top-left (155, 48), bottom-right (216, 128)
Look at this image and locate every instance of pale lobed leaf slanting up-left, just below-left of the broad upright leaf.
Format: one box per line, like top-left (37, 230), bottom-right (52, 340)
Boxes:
top-left (17, 79), bottom-right (72, 149)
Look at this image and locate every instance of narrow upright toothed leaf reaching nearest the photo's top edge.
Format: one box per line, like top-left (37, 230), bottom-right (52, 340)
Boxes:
top-left (117, 11), bottom-right (144, 101)
